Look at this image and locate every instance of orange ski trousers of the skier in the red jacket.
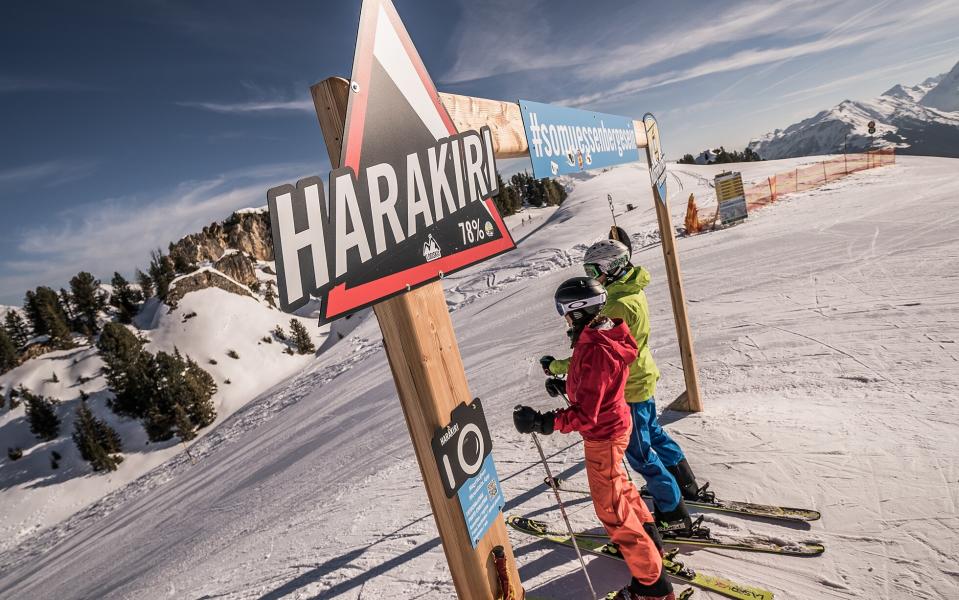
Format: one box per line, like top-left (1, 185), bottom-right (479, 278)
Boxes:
top-left (583, 432), bottom-right (663, 585)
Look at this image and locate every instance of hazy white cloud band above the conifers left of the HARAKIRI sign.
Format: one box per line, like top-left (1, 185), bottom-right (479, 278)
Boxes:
top-left (0, 164), bottom-right (316, 301)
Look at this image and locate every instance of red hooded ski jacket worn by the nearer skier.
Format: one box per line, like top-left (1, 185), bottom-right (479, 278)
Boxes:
top-left (553, 319), bottom-right (637, 441)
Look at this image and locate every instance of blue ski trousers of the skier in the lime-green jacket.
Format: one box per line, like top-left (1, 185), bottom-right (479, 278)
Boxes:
top-left (626, 398), bottom-right (684, 512)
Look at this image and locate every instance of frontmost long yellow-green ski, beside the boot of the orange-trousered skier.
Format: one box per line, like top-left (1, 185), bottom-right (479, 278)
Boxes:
top-left (506, 515), bottom-right (773, 600)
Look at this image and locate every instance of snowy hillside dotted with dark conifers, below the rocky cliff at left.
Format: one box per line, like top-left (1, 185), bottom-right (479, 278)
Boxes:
top-left (0, 288), bottom-right (326, 552)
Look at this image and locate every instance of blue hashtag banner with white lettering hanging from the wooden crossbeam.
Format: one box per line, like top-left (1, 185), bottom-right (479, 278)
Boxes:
top-left (519, 100), bottom-right (639, 179)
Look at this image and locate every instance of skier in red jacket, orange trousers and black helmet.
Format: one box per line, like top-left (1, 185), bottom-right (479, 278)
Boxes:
top-left (513, 277), bottom-right (675, 600)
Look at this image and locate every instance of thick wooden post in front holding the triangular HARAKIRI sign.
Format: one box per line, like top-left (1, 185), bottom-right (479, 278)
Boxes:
top-left (310, 78), bottom-right (525, 600)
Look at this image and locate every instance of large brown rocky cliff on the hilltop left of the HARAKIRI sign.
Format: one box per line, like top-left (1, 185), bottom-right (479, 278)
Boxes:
top-left (170, 209), bottom-right (273, 264)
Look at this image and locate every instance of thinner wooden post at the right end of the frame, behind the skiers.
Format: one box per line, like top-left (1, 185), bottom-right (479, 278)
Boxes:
top-left (646, 147), bottom-right (703, 412)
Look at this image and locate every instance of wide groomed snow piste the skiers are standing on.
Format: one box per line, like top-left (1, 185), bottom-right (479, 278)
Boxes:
top-left (0, 157), bottom-right (959, 600)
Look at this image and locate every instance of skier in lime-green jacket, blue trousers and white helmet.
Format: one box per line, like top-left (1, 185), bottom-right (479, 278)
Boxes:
top-left (540, 240), bottom-right (700, 529)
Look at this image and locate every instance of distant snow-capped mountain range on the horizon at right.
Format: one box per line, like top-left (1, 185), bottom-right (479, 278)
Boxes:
top-left (749, 63), bottom-right (959, 159)
